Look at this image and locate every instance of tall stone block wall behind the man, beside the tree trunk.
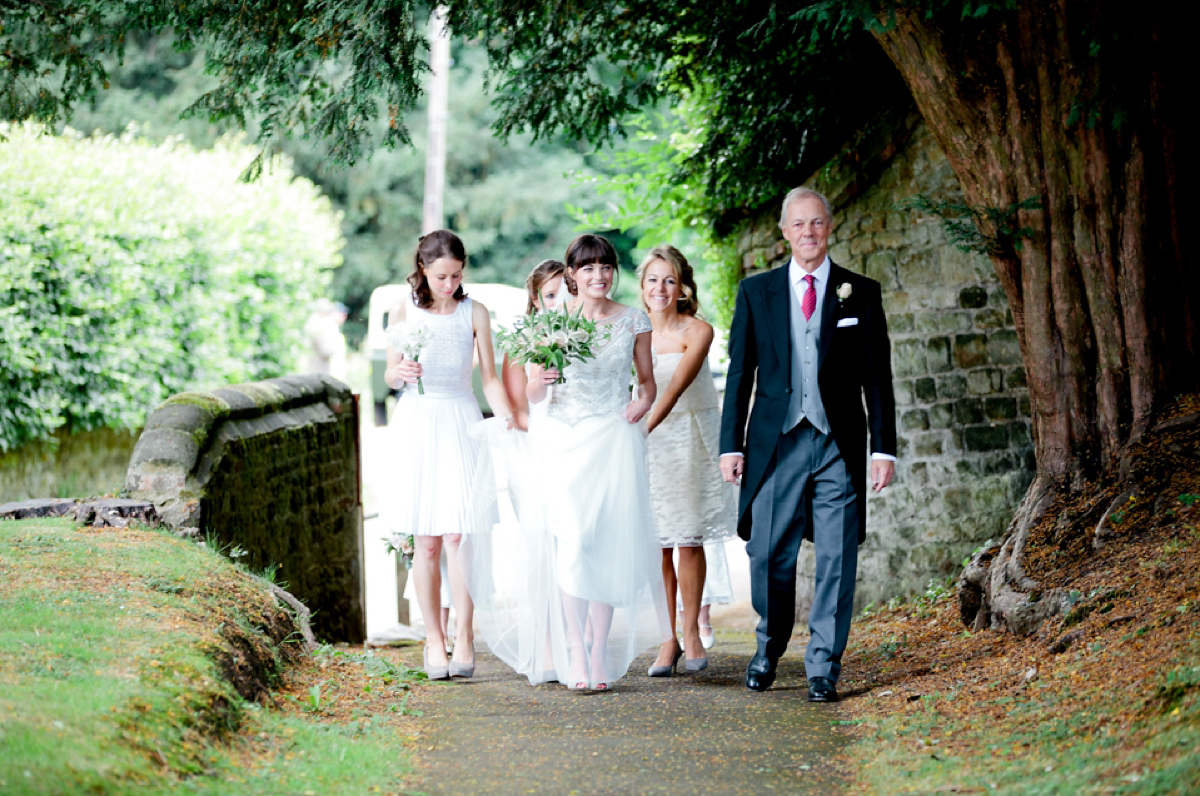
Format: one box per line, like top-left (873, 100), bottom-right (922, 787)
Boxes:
top-left (739, 119), bottom-right (1033, 614)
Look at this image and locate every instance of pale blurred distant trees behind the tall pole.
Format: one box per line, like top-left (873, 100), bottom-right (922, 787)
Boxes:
top-left (49, 34), bottom-right (619, 343)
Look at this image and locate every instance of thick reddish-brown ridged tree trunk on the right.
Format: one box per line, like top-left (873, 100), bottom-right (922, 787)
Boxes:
top-left (876, 0), bottom-right (1198, 632)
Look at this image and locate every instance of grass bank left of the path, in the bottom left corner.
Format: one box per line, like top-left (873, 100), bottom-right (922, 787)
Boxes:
top-left (0, 520), bottom-right (418, 795)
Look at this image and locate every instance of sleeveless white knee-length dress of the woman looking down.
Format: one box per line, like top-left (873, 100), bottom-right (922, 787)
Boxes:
top-left (384, 298), bottom-right (484, 535)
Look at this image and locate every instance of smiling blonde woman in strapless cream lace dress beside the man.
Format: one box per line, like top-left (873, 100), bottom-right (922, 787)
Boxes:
top-left (637, 246), bottom-right (737, 677)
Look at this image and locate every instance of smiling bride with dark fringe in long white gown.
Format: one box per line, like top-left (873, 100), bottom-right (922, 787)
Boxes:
top-left (527, 234), bottom-right (670, 690)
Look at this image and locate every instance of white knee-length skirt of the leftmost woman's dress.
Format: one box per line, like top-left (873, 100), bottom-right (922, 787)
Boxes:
top-left (382, 388), bottom-right (494, 535)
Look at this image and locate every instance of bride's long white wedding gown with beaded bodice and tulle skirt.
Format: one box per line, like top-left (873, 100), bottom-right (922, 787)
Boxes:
top-left (468, 307), bottom-right (670, 684)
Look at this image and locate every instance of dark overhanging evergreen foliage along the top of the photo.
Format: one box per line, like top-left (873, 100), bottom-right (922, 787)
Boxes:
top-left (0, 0), bottom-right (908, 221)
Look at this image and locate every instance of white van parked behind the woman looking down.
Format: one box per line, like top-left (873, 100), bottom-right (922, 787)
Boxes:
top-left (364, 282), bottom-right (526, 426)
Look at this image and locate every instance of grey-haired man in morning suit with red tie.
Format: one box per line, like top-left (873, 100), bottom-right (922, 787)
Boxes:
top-left (721, 188), bottom-right (896, 702)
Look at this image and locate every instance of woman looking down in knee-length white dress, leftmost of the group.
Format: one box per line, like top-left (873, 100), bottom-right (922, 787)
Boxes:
top-left (384, 229), bottom-right (511, 680)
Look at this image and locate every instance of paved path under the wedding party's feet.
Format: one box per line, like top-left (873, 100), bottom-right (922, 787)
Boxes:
top-left (403, 630), bottom-right (846, 796)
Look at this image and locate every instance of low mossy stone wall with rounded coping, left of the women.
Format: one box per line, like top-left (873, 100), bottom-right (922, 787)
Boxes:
top-left (125, 373), bottom-right (366, 642)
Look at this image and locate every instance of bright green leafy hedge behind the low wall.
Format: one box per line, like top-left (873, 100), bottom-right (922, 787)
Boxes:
top-left (0, 126), bottom-right (342, 450)
